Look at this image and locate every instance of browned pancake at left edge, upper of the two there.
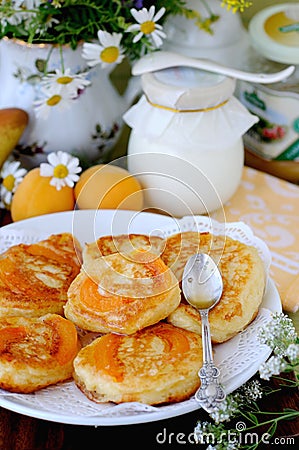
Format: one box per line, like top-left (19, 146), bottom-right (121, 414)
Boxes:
top-left (0, 233), bottom-right (81, 317)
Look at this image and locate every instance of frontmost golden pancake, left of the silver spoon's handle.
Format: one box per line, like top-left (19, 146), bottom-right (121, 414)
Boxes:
top-left (74, 322), bottom-right (202, 405)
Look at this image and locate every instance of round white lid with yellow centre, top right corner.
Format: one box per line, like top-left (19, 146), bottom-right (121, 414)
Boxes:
top-left (249, 3), bottom-right (299, 64)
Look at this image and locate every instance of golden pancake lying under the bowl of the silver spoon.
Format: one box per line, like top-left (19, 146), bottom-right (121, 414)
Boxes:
top-left (167, 233), bottom-right (265, 343)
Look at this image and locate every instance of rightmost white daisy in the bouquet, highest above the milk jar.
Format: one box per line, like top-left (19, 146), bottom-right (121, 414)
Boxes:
top-left (126, 5), bottom-right (166, 47)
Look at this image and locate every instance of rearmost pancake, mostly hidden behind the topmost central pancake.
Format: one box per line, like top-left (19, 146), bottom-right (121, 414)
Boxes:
top-left (83, 234), bottom-right (165, 262)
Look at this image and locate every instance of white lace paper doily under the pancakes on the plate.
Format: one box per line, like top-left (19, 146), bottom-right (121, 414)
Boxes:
top-left (0, 216), bottom-right (281, 425)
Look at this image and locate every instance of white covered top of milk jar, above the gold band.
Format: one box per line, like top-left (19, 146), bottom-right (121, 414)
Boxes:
top-left (141, 67), bottom-right (236, 109)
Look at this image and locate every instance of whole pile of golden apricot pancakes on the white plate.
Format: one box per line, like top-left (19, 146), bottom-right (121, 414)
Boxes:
top-left (0, 232), bottom-right (265, 405)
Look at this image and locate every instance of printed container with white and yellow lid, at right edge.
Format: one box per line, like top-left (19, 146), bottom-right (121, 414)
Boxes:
top-left (236, 3), bottom-right (299, 183)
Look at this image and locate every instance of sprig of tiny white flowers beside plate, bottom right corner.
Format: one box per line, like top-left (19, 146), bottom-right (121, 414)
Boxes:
top-left (194, 313), bottom-right (299, 450)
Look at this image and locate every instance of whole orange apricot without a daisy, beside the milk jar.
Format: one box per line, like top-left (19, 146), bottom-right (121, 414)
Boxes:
top-left (74, 164), bottom-right (143, 211)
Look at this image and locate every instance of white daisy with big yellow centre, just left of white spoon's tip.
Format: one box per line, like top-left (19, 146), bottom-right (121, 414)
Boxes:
top-left (82, 30), bottom-right (125, 67)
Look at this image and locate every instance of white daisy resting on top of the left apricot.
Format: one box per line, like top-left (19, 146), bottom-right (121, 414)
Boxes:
top-left (40, 151), bottom-right (82, 191)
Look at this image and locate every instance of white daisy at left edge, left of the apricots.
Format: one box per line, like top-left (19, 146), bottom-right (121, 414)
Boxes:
top-left (0, 161), bottom-right (27, 209)
